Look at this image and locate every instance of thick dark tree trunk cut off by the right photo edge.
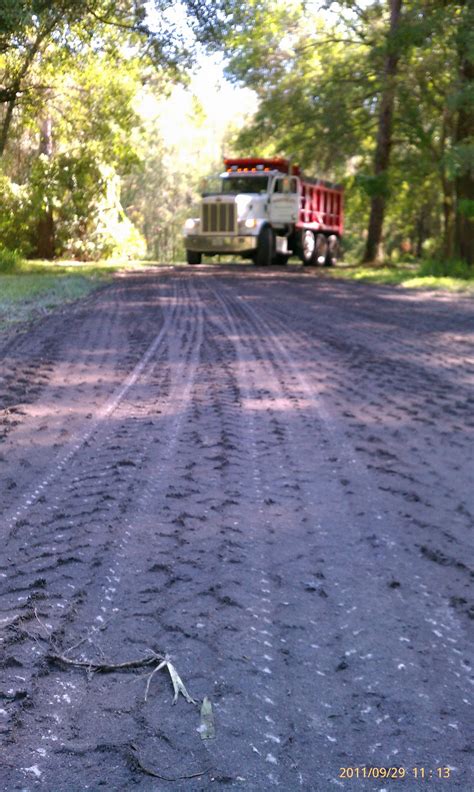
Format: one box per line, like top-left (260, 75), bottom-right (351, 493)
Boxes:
top-left (454, 0), bottom-right (474, 267)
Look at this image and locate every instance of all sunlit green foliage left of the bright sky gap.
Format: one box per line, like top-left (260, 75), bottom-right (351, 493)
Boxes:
top-left (0, 0), bottom-right (209, 259)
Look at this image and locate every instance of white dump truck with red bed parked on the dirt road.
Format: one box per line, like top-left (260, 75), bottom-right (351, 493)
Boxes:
top-left (184, 157), bottom-right (344, 267)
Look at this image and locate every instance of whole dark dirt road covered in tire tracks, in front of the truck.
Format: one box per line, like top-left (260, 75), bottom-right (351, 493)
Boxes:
top-left (0, 267), bottom-right (474, 792)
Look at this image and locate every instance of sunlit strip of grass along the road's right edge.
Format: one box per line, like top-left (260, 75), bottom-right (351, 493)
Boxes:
top-left (327, 261), bottom-right (474, 294)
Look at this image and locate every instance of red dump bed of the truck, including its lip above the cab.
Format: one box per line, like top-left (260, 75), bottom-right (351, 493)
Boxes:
top-left (224, 157), bottom-right (344, 236)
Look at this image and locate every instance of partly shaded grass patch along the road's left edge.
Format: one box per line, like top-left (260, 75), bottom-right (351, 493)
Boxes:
top-left (0, 257), bottom-right (150, 330)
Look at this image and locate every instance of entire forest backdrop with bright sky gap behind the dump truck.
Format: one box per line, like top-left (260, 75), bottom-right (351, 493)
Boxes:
top-left (0, 0), bottom-right (474, 273)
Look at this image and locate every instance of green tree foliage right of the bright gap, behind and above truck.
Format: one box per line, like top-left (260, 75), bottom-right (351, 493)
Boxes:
top-left (209, 0), bottom-right (474, 266)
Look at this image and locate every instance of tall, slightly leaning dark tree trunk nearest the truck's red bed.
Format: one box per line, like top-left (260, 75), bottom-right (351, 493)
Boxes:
top-left (363, 0), bottom-right (403, 264)
